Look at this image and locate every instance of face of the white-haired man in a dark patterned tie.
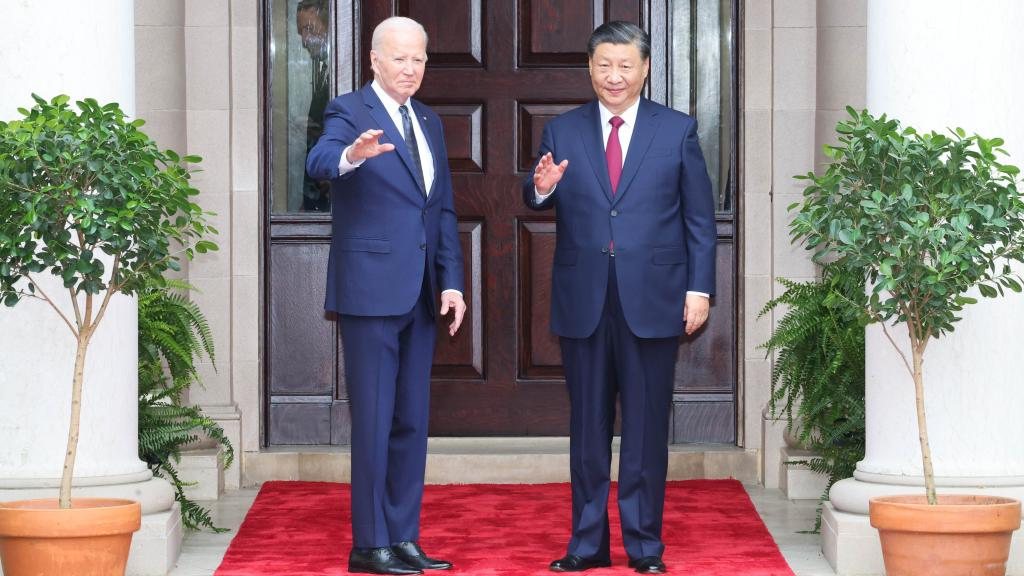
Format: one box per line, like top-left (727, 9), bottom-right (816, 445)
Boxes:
top-left (370, 29), bottom-right (427, 104)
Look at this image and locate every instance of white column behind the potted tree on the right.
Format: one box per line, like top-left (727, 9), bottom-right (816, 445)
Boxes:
top-left (822, 0), bottom-right (1024, 574)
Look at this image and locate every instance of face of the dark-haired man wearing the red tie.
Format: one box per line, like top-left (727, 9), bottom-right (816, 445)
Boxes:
top-left (590, 42), bottom-right (650, 115)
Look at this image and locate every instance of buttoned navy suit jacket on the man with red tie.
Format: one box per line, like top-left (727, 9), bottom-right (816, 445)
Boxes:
top-left (522, 98), bottom-right (716, 338)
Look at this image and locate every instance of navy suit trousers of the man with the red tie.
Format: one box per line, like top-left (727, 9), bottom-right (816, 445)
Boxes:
top-left (560, 257), bottom-right (683, 560)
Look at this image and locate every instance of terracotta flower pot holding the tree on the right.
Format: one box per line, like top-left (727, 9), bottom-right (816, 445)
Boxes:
top-left (868, 494), bottom-right (1021, 576)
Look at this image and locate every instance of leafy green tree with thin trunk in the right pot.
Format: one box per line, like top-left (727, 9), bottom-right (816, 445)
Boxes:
top-left (791, 108), bottom-right (1024, 504)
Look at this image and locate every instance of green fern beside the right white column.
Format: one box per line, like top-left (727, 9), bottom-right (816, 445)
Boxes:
top-left (760, 263), bottom-right (867, 531)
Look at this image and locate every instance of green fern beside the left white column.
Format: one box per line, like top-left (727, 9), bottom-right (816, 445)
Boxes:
top-left (138, 279), bottom-right (234, 532)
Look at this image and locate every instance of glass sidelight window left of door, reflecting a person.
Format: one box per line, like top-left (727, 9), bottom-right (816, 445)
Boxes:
top-left (266, 0), bottom-right (333, 214)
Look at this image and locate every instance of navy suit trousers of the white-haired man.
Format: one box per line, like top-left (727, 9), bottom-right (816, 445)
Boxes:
top-left (340, 272), bottom-right (437, 548)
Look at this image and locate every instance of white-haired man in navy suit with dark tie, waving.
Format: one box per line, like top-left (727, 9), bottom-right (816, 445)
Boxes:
top-left (306, 17), bottom-right (466, 574)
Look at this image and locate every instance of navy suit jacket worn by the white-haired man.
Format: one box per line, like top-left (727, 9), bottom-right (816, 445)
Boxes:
top-left (306, 84), bottom-right (463, 316)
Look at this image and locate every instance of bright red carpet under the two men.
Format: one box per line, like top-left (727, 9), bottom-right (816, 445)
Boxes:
top-left (216, 480), bottom-right (793, 576)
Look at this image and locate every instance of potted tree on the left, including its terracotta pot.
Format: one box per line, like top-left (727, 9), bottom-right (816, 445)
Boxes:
top-left (0, 94), bottom-right (216, 576)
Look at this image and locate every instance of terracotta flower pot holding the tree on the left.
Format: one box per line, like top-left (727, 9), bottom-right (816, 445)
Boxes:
top-left (0, 498), bottom-right (142, 576)
